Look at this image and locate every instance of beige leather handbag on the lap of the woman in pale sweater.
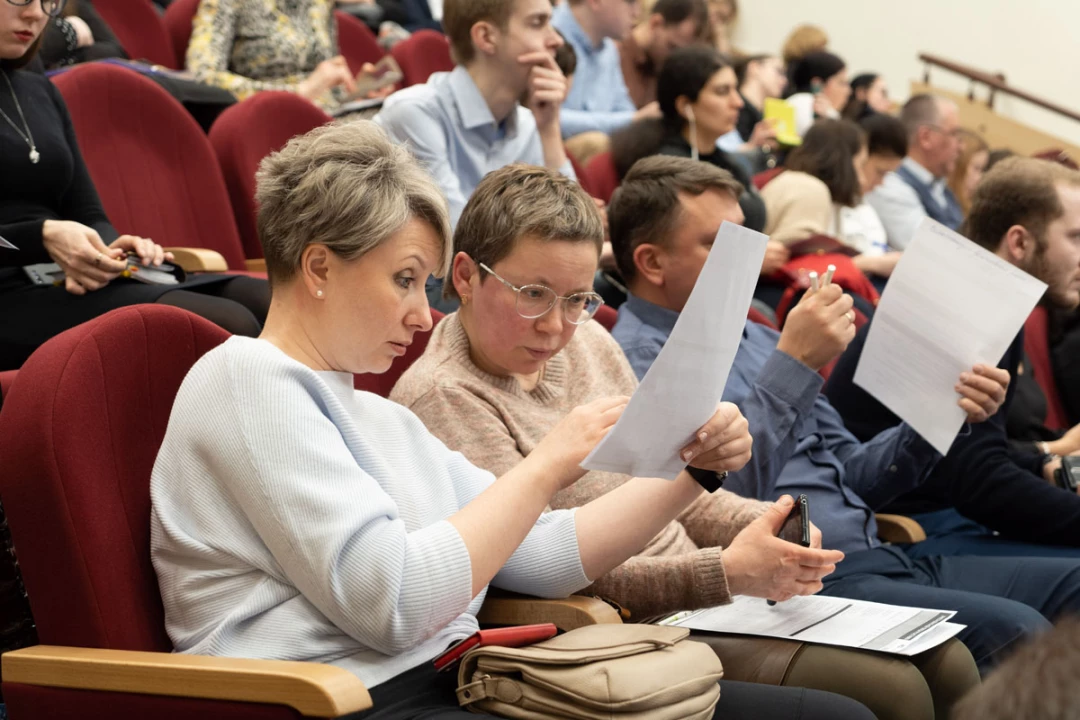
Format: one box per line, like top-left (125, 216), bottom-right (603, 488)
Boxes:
top-left (458, 625), bottom-right (724, 720)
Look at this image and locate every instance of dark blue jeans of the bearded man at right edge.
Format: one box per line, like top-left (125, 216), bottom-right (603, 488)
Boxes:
top-left (897, 508), bottom-right (1080, 560)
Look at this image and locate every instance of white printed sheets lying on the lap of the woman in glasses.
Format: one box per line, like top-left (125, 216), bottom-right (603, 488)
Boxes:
top-left (663, 595), bottom-right (964, 655)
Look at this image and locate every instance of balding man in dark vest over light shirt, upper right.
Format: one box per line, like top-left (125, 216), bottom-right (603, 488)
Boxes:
top-left (866, 95), bottom-right (963, 250)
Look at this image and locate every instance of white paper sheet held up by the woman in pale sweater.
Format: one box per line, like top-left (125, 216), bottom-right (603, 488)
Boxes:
top-left (581, 222), bottom-right (769, 480)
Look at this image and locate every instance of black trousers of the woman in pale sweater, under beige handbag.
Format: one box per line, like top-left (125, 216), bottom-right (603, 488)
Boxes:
top-left (352, 663), bottom-right (874, 720)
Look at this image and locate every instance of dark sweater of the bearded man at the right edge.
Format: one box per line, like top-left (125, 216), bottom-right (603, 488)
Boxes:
top-left (825, 324), bottom-right (1080, 546)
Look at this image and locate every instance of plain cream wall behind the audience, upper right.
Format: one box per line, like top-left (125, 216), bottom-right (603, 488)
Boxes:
top-left (734, 0), bottom-right (1080, 145)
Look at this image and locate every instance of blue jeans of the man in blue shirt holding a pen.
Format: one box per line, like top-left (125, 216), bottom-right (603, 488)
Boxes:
top-left (822, 546), bottom-right (1080, 675)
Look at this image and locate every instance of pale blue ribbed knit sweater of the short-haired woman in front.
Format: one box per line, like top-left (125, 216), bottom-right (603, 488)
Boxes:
top-left (150, 338), bottom-right (589, 687)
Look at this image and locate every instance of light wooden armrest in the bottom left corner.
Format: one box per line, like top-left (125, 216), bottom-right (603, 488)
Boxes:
top-left (2, 646), bottom-right (372, 718)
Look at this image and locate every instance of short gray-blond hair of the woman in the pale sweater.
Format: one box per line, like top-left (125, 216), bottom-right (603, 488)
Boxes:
top-left (255, 120), bottom-right (451, 285)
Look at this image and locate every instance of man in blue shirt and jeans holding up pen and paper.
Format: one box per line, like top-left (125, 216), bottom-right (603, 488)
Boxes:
top-left (608, 158), bottom-right (1080, 673)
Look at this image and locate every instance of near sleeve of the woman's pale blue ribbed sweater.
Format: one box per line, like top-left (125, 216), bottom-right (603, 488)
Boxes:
top-left (212, 358), bottom-right (481, 655)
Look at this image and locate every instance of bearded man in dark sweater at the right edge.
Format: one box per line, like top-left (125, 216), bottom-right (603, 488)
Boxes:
top-left (827, 158), bottom-right (1080, 557)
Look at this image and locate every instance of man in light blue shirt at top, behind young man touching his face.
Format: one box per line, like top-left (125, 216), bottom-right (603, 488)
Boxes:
top-left (552, 0), bottom-right (660, 137)
